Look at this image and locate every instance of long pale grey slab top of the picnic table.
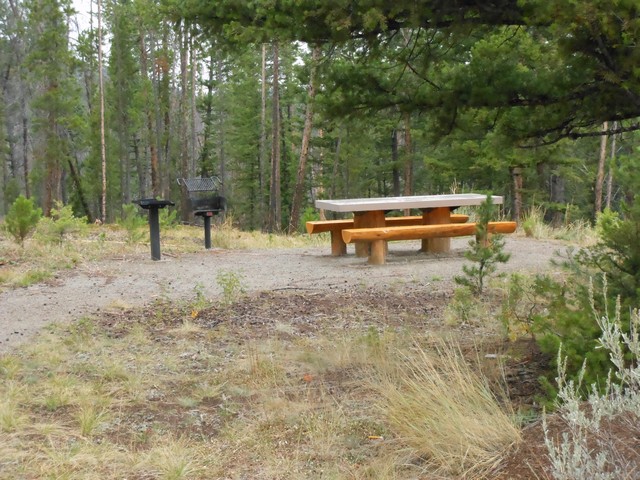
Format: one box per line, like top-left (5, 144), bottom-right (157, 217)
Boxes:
top-left (316, 193), bottom-right (503, 212)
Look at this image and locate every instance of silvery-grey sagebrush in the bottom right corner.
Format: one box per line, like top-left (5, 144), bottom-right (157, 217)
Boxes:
top-left (543, 284), bottom-right (640, 480)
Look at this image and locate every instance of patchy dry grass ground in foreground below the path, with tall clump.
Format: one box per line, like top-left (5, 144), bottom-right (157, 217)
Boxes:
top-left (0, 288), bottom-right (517, 480)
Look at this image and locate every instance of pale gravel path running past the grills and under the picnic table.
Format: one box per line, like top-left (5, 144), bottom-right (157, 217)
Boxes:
top-left (0, 237), bottom-right (564, 352)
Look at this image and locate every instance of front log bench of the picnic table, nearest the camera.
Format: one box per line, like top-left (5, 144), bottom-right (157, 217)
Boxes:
top-left (342, 222), bottom-right (517, 265)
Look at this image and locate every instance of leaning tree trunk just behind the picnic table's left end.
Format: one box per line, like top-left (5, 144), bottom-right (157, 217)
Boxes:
top-left (289, 46), bottom-right (320, 233)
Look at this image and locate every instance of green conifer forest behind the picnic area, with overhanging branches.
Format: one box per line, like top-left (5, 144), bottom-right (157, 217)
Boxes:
top-left (0, 0), bottom-right (640, 232)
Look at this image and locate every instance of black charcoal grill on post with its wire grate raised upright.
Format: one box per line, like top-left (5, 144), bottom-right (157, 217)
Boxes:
top-left (178, 177), bottom-right (227, 250)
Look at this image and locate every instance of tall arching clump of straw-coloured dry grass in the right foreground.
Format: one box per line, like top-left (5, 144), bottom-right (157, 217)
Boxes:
top-left (373, 340), bottom-right (520, 478)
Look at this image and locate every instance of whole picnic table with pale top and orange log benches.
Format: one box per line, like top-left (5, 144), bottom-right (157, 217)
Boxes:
top-left (307, 193), bottom-right (515, 264)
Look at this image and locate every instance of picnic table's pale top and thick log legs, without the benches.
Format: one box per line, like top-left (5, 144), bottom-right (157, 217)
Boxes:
top-left (315, 193), bottom-right (503, 257)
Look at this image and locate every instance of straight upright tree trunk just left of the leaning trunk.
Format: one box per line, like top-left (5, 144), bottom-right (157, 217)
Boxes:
top-left (267, 42), bottom-right (282, 232)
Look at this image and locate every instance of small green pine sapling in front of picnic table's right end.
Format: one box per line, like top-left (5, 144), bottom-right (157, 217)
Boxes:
top-left (454, 195), bottom-right (510, 294)
